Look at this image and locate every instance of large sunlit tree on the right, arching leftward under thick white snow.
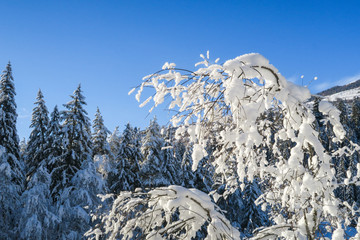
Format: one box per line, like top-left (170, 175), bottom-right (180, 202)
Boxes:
top-left (132, 54), bottom-right (359, 239)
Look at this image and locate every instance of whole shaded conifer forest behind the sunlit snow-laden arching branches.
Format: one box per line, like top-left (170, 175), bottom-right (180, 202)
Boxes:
top-left (0, 64), bottom-right (360, 239)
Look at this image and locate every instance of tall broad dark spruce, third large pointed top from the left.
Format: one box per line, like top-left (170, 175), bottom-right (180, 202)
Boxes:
top-left (53, 85), bottom-right (105, 239)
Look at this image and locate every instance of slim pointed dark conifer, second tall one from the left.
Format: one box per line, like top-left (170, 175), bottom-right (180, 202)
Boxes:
top-left (26, 90), bottom-right (49, 181)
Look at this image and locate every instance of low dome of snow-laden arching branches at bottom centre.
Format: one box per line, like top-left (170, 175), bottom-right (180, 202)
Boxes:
top-left (85, 185), bottom-right (240, 239)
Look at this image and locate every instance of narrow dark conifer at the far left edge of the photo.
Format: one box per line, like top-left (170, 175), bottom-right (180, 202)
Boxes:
top-left (0, 62), bottom-right (23, 184)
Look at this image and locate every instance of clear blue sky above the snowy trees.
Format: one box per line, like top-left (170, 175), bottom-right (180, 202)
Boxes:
top-left (0, 0), bottom-right (360, 138)
